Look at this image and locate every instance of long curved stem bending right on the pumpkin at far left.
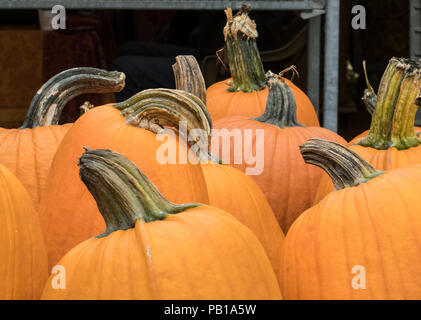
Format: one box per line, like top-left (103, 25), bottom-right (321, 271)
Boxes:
top-left (20, 68), bottom-right (126, 129)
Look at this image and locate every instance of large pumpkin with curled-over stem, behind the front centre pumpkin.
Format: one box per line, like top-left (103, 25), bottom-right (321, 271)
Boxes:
top-left (40, 89), bottom-right (210, 266)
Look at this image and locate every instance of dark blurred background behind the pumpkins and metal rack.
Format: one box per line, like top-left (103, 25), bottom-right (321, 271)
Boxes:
top-left (0, 0), bottom-right (410, 140)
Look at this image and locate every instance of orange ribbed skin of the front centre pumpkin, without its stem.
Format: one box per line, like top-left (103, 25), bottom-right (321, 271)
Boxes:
top-left (42, 206), bottom-right (282, 300)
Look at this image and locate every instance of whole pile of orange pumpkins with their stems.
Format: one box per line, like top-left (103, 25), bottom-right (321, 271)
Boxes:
top-left (0, 7), bottom-right (421, 299)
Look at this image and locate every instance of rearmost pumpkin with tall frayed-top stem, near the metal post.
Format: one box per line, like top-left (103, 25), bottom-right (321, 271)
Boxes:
top-left (206, 5), bottom-right (319, 127)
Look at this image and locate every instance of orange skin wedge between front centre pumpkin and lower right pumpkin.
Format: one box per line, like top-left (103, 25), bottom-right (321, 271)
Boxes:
top-left (202, 164), bottom-right (285, 275)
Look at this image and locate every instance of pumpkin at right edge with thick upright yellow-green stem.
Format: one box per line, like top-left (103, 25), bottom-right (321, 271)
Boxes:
top-left (314, 58), bottom-right (421, 203)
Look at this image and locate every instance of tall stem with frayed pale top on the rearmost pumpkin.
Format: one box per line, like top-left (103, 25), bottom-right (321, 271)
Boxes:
top-left (224, 4), bottom-right (265, 92)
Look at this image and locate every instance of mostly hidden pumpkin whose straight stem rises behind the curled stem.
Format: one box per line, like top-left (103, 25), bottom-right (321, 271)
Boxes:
top-left (173, 56), bottom-right (284, 275)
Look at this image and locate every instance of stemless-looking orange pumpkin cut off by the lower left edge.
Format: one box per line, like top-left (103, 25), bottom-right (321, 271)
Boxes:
top-left (0, 165), bottom-right (48, 300)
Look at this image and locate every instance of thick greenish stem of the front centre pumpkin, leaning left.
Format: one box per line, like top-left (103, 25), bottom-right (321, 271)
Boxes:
top-left (78, 148), bottom-right (200, 238)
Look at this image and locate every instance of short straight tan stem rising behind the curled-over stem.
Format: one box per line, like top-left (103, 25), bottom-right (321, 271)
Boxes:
top-left (172, 56), bottom-right (221, 163)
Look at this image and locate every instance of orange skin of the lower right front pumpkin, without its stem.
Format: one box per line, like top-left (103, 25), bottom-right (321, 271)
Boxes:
top-left (281, 165), bottom-right (421, 300)
